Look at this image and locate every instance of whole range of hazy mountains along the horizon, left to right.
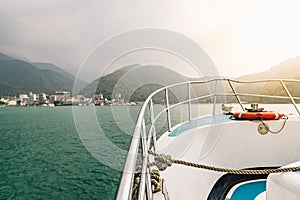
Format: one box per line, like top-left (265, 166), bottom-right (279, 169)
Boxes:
top-left (0, 53), bottom-right (300, 101)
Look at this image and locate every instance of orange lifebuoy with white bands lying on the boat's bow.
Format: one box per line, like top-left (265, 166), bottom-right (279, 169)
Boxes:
top-left (233, 111), bottom-right (284, 120)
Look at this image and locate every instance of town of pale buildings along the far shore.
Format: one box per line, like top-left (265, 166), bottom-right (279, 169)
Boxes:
top-left (0, 91), bottom-right (143, 107)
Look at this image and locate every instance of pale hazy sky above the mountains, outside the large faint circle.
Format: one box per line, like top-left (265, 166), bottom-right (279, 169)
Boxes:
top-left (0, 0), bottom-right (300, 79)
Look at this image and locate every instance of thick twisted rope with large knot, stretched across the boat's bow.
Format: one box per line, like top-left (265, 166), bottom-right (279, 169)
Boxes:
top-left (149, 151), bottom-right (300, 175)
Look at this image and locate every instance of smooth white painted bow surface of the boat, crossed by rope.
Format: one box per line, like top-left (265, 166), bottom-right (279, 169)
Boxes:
top-left (156, 118), bottom-right (300, 200)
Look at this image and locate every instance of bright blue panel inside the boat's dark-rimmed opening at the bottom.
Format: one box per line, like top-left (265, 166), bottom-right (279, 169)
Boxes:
top-left (230, 181), bottom-right (266, 200)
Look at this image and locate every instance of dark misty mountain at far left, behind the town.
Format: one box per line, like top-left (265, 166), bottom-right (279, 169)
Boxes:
top-left (0, 53), bottom-right (86, 96)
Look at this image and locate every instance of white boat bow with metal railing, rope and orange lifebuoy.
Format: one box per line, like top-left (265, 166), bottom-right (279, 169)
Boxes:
top-left (117, 78), bottom-right (300, 200)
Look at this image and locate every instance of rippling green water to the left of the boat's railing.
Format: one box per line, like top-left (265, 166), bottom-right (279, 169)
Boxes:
top-left (0, 106), bottom-right (140, 199)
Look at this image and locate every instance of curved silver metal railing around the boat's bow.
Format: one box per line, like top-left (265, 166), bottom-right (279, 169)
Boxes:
top-left (117, 78), bottom-right (300, 200)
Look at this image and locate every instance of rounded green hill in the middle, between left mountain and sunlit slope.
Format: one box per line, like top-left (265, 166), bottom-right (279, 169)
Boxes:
top-left (80, 65), bottom-right (187, 101)
